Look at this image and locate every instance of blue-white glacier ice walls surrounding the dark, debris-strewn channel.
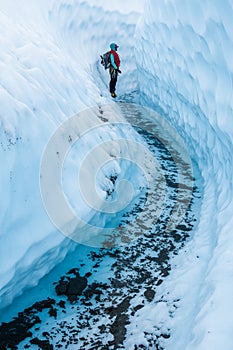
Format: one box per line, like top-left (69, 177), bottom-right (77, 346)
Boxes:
top-left (0, 0), bottom-right (233, 350)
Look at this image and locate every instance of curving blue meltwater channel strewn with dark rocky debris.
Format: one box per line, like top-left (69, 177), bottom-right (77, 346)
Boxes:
top-left (0, 103), bottom-right (200, 350)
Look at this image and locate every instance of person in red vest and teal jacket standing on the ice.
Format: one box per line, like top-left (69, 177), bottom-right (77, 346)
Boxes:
top-left (109, 43), bottom-right (121, 98)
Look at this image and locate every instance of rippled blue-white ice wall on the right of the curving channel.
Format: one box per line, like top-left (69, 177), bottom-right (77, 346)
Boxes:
top-left (136, 0), bottom-right (233, 350)
